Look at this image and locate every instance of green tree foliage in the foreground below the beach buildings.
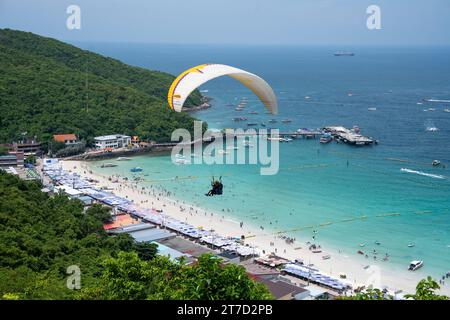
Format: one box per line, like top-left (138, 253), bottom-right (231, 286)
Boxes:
top-left (0, 171), bottom-right (271, 299)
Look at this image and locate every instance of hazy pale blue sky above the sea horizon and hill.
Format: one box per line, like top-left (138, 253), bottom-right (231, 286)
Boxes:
top-left (0, 0), bottom-right (450, 45)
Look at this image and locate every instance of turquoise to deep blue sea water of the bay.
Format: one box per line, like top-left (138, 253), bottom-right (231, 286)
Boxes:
top-left (78, 44), bottom-right (450, 276)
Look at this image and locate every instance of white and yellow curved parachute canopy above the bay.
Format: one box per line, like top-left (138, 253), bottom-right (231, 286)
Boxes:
top-left (167, 64), bottom-right (278, 114)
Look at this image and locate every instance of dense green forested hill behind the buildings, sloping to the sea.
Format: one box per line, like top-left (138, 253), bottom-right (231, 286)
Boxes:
top-left (0, 29), bottom-right (201, 142)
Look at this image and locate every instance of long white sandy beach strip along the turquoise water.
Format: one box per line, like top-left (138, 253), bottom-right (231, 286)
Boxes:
top-left (61, 161), bottom-right (450, 294)
